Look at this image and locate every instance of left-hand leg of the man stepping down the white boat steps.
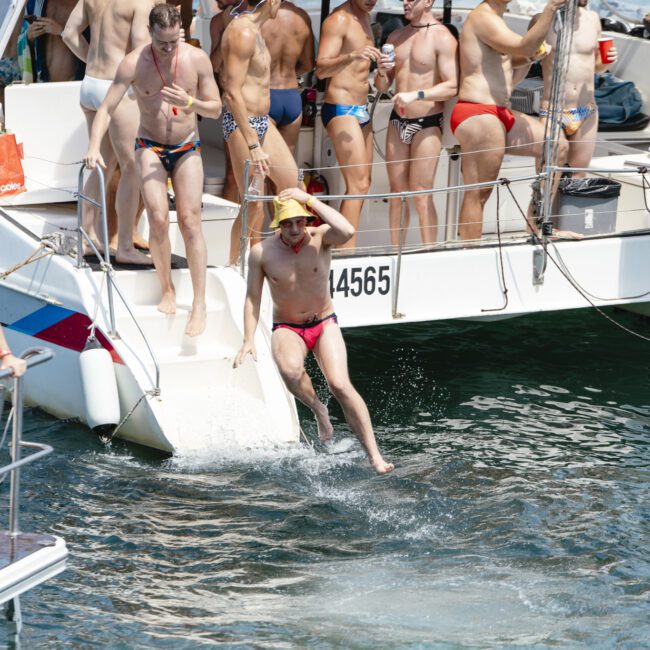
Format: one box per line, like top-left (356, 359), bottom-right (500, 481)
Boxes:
top-left (135, 148), bottom-right (176, 314)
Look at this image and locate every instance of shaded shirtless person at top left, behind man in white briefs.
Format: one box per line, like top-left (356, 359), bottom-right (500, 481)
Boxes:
top-left (25, 0), bottom-right (83, 81)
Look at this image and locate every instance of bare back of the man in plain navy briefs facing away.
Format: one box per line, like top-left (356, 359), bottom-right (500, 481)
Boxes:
top-left (262, 1), bottom-right (314, 88)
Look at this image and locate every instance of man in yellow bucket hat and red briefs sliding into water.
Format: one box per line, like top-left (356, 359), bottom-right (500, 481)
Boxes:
top-left (233, 188), bottom-right (394, 474)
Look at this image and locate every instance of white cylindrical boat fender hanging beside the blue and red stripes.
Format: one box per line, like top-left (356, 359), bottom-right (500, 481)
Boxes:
top-left (79, 337), bottom-right (120, 430)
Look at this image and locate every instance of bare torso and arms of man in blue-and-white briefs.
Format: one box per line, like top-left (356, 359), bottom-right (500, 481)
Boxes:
top-left (317, 0), bottom-right (375, 105)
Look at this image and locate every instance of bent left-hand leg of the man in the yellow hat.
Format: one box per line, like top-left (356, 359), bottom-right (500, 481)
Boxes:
top-left (271, 328), bottom-right (334, 441)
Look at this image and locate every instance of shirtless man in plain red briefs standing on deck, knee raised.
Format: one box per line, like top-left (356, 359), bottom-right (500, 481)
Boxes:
top-left (451, 0), bottom-right (567, 239)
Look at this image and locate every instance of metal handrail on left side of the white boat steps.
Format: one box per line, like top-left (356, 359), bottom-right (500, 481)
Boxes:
top-left (77, 163), bottom-right (160, 395)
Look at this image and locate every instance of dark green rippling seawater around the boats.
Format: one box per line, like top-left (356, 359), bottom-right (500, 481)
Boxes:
top-left (0, 311), bottom-right (650, 650)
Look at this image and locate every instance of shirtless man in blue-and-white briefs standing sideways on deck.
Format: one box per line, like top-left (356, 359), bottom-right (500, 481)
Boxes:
top-left (316, 0), bottom-right (392, 248)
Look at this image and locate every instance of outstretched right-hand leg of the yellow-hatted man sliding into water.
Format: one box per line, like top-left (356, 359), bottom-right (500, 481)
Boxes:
top-left (314, 323), bottom-right (394, 474)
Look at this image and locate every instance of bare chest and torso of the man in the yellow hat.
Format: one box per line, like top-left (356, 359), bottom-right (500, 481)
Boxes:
top-left (261, 226), bottom-right (334, 323)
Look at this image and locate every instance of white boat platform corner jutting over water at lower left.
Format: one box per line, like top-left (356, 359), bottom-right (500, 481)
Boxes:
top-left (0, 532), bottom-right (68, 604)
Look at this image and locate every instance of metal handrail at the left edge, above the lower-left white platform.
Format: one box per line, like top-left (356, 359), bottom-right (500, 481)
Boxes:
top-left (0, 348), bottom-right (54, 537)
